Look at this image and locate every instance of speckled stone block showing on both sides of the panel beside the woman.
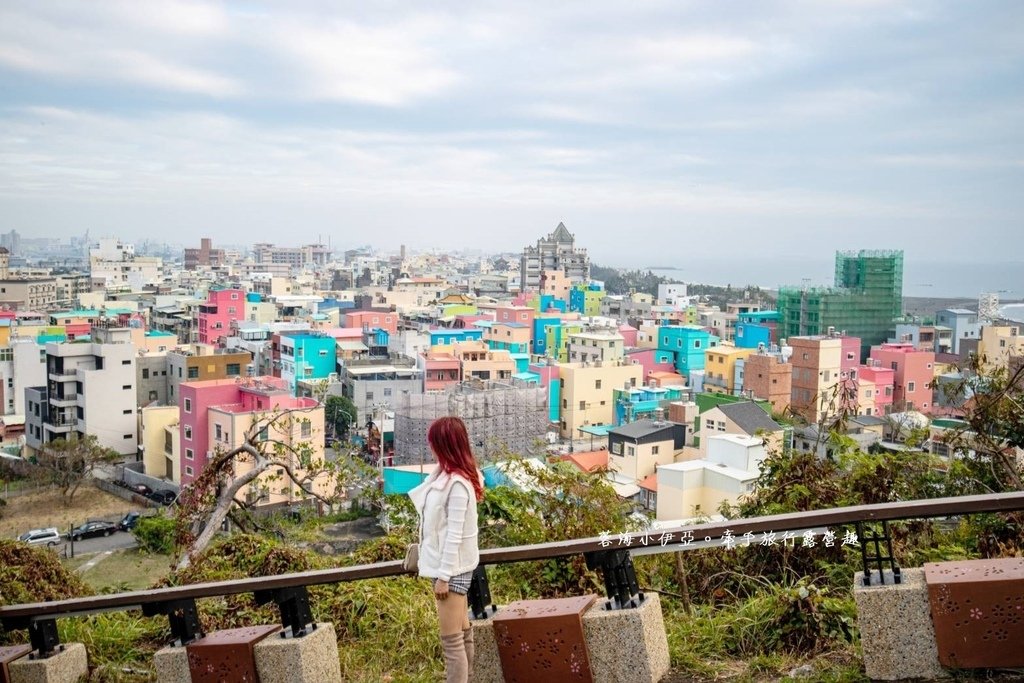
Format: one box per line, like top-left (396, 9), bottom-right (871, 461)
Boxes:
top-left (470, 593), bottom-right (669, 683)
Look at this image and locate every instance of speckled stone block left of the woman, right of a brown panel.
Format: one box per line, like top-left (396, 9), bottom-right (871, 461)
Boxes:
top-left (253, 624), bottom-right (341, 683)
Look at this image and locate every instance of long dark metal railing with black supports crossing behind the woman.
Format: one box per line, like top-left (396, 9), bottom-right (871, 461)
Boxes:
top-left (0, 492), bottom-right (1024, 656)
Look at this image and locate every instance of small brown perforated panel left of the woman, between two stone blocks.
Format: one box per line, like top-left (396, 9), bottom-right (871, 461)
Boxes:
top-left (185, 626), bottom-right (281, 683)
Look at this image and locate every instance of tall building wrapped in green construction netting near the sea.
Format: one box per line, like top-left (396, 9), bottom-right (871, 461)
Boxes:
top-left (778, 250), bottom-right (903, 359)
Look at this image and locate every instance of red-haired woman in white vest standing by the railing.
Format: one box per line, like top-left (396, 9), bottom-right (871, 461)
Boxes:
top-left (409, 417), bottom-right (483, 683)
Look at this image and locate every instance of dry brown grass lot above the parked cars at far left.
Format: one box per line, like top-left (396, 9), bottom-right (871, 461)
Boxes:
top-left (0, 484), bottom-right (138, 539)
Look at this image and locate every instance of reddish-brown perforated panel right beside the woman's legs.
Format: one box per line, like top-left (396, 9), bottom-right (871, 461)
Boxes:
top-left (494, 595), bottom-right (597, 683)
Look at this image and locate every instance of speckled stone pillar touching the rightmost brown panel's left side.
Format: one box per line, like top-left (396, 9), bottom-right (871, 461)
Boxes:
top-left (853, 569), bottom-right (948, 681)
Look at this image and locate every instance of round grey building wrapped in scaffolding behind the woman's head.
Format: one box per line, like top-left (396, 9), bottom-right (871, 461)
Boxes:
top-left (394, 381), bottom-right (549, 465)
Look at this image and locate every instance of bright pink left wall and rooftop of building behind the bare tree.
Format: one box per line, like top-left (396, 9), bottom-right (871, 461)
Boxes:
top-left (178, 377), bottom-right (316, 485)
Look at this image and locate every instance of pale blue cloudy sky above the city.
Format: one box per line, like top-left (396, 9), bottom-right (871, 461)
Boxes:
top-left (0, 0), bottom-right (1024, 272)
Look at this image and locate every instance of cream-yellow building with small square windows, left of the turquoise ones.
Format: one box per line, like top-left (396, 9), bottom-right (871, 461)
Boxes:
top-left (558, 362), bottom-right (643, 438)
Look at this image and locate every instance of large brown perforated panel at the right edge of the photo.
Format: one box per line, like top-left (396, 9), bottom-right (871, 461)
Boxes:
top-left (925, 558), bottom-right (1024, 669)
